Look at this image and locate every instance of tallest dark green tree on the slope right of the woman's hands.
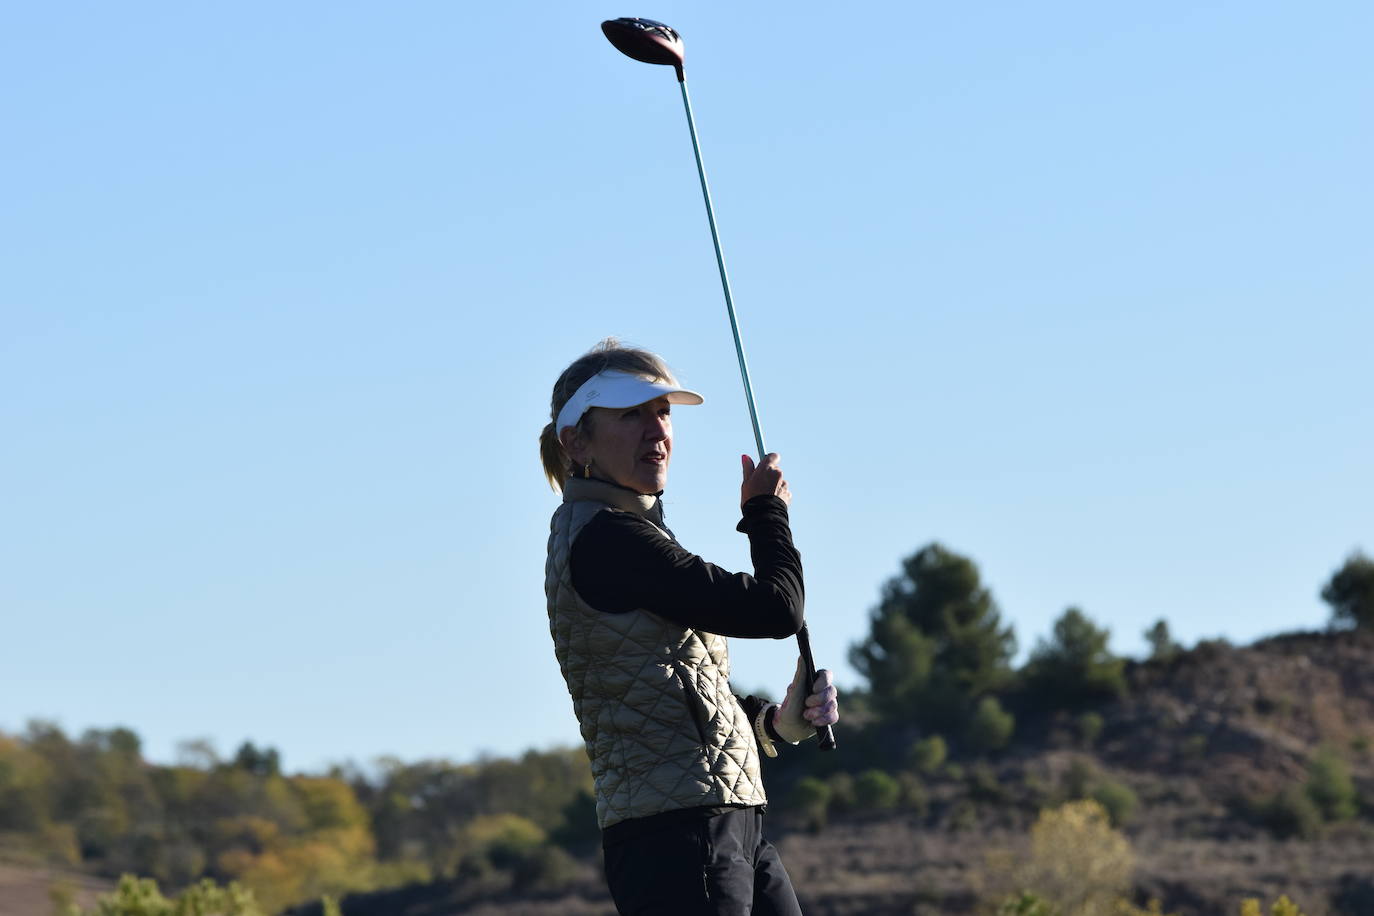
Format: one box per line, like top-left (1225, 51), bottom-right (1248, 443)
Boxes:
top-left (849, 544), bottom-right (1015, 731)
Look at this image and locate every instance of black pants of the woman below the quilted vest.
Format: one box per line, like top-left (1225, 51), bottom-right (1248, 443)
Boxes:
top-left (606, 808), bottom-right (801, 916)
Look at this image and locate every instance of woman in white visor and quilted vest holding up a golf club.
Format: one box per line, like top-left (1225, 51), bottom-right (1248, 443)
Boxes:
top-left (540, 339), bottom-right (838, 915)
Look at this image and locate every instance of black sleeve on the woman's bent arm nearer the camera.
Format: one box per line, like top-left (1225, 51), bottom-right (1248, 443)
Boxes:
top-left (570, 496), bottom-right (805, 639)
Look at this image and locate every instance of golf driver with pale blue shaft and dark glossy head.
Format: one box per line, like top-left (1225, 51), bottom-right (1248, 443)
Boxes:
top-left (602, 18), bottom-right (835, 751)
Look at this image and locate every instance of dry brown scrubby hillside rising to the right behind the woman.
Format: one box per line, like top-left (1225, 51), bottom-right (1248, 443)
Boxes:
top-left (281, 632), bottom-right (1374, 916)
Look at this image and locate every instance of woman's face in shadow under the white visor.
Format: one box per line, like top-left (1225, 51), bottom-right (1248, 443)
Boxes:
top-left (573, 397), bottom-right (673, 494)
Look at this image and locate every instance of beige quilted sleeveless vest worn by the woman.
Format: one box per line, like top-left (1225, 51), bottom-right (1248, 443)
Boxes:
top-left (544, 478), bottom-right (768, 829)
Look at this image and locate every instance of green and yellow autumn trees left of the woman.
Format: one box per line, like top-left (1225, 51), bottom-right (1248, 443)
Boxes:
top-left (0, 721), bottom-right (599, 912)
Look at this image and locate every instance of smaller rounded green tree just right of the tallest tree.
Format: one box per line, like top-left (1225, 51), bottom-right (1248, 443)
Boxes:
top-left (1024, 607), bottom-right (1125, 709)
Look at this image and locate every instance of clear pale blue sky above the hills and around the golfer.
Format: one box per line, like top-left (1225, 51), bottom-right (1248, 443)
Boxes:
top-left (0, 1), bottom-right (1374, 769)
